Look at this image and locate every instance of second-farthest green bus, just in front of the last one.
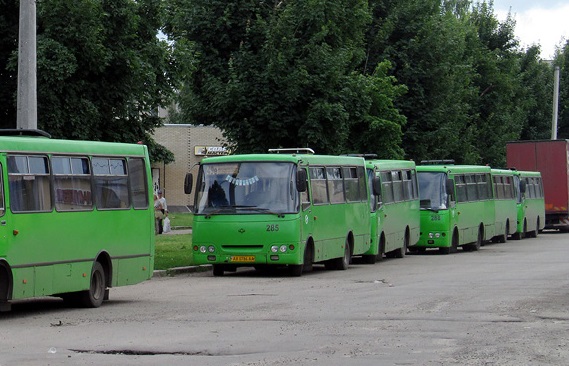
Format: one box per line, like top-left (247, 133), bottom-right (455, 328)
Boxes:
top-left (491, 169), bottom-right (518, 243)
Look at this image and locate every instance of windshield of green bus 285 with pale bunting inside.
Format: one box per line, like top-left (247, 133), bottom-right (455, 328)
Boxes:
top-left (195, 162), bottom-right (299, 214)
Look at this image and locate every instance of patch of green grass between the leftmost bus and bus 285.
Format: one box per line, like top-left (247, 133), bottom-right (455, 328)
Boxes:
top-left (154, 234), bottom-right (192, 270)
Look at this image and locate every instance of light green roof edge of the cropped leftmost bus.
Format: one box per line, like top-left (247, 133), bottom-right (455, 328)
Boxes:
top-left (0, 136), bottom-right (146, 156)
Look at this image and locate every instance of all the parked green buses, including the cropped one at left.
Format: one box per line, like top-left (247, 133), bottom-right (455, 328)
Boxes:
top-left (0, 130), bottom-right (545, 311)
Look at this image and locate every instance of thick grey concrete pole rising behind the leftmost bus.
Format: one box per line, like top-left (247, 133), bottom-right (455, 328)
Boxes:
top-left (16, 0), bottom-right (38, 129)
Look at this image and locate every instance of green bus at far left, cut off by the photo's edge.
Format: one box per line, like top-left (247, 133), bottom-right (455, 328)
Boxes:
top-left (0, 130), bottom-right (154, 311)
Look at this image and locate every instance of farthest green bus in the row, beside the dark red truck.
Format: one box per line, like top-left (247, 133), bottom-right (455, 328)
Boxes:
top-left (512, 171), bottom-right (545, 240)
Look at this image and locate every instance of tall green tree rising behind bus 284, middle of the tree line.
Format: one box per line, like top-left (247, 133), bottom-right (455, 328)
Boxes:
top-left (362, 0), bottom-right (475, 162)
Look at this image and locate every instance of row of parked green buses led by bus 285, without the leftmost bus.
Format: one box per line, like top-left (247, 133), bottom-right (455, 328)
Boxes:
top-left (185, 149), bottom-right (545, 276)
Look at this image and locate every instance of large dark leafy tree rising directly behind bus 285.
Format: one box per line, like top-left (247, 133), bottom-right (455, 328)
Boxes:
top-left (166, 0), bottom-right (404, 156)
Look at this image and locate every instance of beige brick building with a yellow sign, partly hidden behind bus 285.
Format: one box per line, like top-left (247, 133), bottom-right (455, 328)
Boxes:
top-left (152, 124), bottom-right (225, 212)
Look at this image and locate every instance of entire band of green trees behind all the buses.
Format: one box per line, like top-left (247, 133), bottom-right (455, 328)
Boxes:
top-left (0, 0), bottom-right (569, 167)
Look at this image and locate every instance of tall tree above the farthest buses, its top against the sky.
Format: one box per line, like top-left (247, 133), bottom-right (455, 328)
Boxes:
top-left (469, 2), bottom-right (528, 167)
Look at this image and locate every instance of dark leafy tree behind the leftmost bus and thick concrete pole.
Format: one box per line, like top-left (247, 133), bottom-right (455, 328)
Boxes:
top-left (1, 0), bottom-right (180, 162)
